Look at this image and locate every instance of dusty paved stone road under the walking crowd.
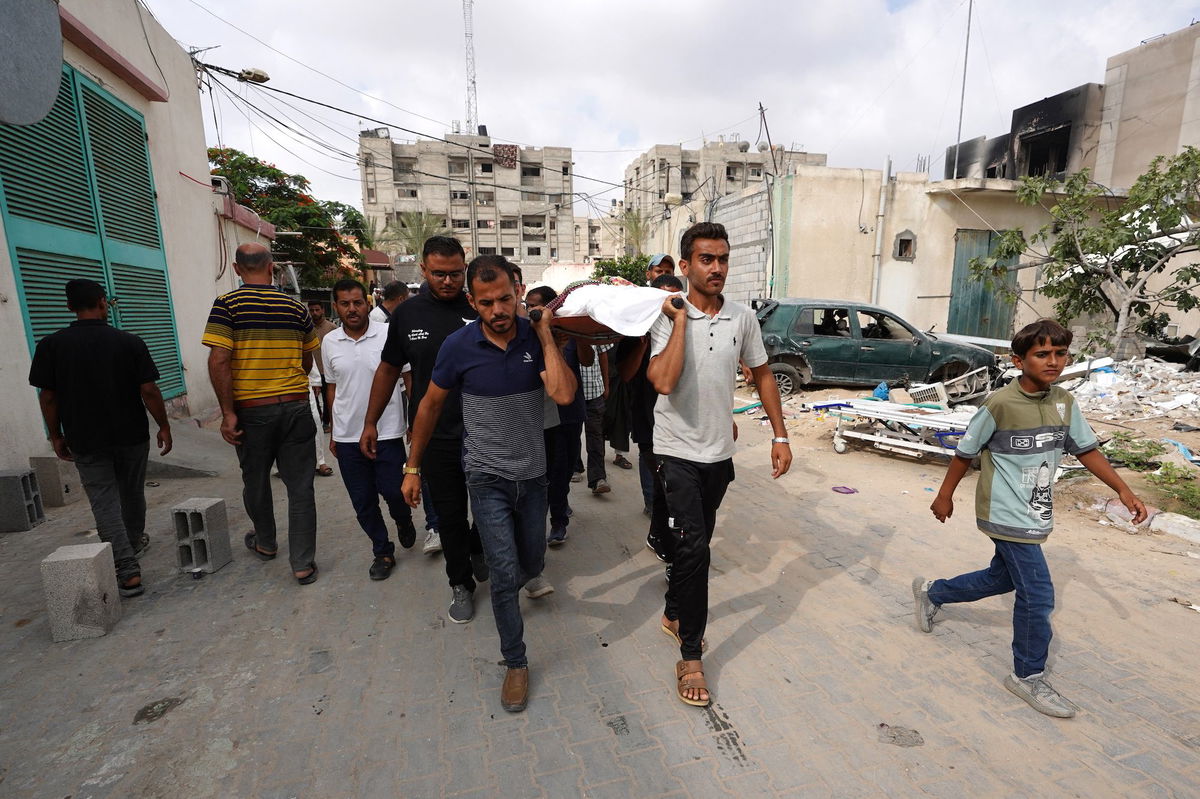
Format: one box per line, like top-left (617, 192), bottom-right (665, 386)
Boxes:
top-left (0, 419), bottom-right (1200, 799)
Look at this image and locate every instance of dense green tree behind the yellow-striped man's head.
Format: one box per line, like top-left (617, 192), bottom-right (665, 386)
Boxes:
top-left (209, 148), bottom-right (370, 286)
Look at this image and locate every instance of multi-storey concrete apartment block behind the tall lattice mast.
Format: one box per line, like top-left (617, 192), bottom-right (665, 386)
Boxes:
top-left (359, 127), bottom-right (576, 268)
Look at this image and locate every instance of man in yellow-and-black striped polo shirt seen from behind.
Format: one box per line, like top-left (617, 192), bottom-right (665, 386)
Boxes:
top-left (202, 244), bottom-right (319, 585)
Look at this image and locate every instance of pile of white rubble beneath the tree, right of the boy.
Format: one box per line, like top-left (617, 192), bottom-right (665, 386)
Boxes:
top-left (1064, 358), bottom-right (1200, 421)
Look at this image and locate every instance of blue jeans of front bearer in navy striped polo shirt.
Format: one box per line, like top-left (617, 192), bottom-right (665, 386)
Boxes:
top-left (467, 471), bottom-right (546, 668)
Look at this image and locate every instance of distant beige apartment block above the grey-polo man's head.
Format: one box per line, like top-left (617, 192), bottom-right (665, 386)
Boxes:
top-left (625, 137), bottom-right (826, 218)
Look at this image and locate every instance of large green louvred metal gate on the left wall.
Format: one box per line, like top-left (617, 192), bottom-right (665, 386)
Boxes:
top-left (0, 65), bottom-right (187, 398)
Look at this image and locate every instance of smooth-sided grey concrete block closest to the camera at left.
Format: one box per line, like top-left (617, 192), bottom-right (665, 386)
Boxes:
top-left (42, 541), bottom-right (121, 641)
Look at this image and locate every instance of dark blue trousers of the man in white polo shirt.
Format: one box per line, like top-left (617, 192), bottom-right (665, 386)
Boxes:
top-left (334, 438), bottom-right (413, 557)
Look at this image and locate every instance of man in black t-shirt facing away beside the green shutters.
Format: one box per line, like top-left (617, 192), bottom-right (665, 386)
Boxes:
top-left (29, 280), bottom-right (172, 596)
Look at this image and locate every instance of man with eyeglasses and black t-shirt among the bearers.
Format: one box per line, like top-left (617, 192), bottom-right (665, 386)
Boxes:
top-left (359, 236), bottom-right (487, 624)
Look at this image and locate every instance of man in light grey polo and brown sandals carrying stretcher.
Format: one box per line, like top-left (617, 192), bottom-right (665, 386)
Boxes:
top-left (647, 222), bottom-right (792, 707)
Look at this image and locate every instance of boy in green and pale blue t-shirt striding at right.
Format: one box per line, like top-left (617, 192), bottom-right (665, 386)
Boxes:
top-left (912, 319), bottom-right (1146, 719)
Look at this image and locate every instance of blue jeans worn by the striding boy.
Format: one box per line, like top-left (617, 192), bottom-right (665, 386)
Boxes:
top-left (929, 539), bottom-right (1054, 678)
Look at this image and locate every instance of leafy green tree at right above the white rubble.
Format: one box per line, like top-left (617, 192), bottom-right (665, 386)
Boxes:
top-left (971, 148), bottom-right (1200, 355)
